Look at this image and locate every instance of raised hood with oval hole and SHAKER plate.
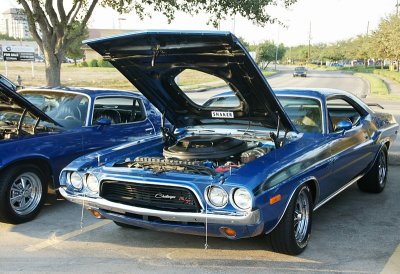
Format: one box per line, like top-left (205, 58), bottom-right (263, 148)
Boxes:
top-left (84, 31), bottom-right (294, 131)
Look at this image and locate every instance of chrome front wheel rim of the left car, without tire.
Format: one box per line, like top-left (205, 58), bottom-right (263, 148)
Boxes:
top-left (10, 172), bottom-right (42, 215)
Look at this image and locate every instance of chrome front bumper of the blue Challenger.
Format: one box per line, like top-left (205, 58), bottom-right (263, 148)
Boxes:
top-left (59, 187), bottom-right (260, 225)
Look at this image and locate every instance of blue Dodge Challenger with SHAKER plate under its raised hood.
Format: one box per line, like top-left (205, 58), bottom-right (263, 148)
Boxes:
top-left (60, 31), bottom-right (398, 254)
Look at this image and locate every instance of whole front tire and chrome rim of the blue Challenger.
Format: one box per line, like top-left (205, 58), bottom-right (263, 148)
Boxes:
top-left (269, 185), bottom-right (313, 255)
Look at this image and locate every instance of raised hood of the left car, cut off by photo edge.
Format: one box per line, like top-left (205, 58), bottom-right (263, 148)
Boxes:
top-left (0, 74), bottom-right (62, 127)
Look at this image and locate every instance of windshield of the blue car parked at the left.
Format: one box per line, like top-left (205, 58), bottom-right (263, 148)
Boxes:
top-left (20, 91), bottom-right (89, 128)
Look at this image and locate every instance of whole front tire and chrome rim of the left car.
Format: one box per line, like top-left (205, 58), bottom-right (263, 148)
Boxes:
top-left (0, 165), bottom-right (47, 224)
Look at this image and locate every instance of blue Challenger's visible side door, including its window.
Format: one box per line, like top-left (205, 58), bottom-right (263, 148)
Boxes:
top-left (327, 96), bottom-right (374, 189)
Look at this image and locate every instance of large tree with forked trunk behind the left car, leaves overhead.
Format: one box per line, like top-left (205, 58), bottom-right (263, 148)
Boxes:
top-left (17, 0), bottom-right (297, 86)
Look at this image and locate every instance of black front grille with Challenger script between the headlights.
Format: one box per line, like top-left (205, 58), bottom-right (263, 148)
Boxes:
top-left (100, 180), bottom-right (200, 212)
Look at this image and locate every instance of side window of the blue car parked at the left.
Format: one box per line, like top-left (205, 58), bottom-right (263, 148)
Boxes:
top-left (92, 97), bottom-right (146, 124)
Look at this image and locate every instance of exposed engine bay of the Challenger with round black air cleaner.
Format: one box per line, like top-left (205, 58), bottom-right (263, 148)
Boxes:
top-left (115, 135), bottom-right (274, 176)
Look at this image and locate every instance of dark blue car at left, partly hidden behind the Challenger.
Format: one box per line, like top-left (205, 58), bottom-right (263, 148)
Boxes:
top-left (0, 75), bottom-right (161, 223)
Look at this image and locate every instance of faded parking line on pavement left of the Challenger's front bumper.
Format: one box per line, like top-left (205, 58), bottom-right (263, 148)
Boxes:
top-left (24, 220), bottom-right (111, 252)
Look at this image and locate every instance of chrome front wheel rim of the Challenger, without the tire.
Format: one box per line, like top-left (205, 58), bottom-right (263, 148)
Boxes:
top-left (293, 189), bottom-right (310, 247)
